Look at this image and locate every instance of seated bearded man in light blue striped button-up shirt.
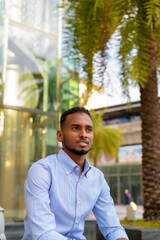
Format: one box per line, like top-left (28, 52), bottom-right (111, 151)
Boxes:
top-left (23, 107), bottom-right (128, 240)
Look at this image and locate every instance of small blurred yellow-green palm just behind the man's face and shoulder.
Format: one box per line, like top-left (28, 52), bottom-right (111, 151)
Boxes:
top-left (88, 111), bottom-right (124, 167)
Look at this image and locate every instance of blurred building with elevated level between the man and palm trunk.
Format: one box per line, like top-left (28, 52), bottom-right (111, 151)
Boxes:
top-left (96, 102), bottom-right (142, 204)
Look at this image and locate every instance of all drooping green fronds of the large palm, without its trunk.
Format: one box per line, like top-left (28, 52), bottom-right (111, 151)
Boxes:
top-left (64, 0), bottom-right (160, 95)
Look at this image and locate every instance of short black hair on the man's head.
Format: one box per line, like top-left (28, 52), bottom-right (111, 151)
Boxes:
top-left (60, 107), bottom-right (92, 127)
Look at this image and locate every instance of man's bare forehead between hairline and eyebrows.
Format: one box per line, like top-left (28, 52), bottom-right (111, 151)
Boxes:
top-left (64, 113), bottom-right (93, 126)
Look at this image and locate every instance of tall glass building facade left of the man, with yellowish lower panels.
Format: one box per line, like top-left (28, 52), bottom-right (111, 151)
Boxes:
top-left (0, 0), bottom-right (58, 220)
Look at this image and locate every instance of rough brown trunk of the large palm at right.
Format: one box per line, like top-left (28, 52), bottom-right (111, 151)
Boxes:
top-left (140, 27), bottom-right (160, 220)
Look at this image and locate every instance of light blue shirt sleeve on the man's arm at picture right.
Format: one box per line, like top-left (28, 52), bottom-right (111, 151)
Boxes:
top-left (93, 173), bottom-right (128, 240)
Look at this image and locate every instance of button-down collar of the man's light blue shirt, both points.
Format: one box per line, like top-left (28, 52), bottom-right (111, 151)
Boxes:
top-left (58, 149), bottom-right (91, 177)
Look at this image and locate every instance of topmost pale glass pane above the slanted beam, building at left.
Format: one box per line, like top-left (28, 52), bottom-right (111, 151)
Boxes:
top-left (9, 0), bottom-right (57, 34)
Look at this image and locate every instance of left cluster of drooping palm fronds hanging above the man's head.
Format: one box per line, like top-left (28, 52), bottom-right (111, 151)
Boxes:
top-left (60, 0), bottom-right (117, 91)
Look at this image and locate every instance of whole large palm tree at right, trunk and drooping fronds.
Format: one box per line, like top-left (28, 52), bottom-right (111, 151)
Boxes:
top-left (61, 0), bottom-right (160, 220)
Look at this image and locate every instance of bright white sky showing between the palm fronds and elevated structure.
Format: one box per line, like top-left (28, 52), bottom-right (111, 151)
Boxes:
top-left (86, 35), bottom-right (140, 109)
